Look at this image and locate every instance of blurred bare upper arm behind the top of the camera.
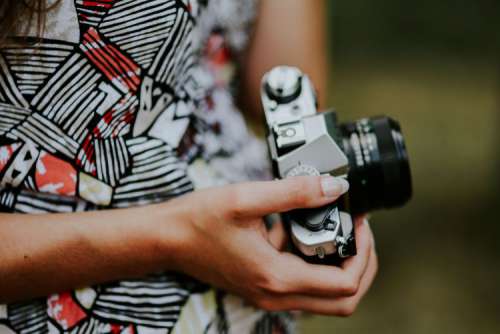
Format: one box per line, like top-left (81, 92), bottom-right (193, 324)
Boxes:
top-left (240, 0), bottom-right (328, 117)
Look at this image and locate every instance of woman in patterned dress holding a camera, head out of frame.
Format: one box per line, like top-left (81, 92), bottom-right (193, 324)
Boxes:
top-left (0, 0), bottom-right (377, 333)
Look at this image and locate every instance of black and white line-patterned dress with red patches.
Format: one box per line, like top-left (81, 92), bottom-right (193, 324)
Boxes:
top-left (0, 0), bottom-right (292, 334)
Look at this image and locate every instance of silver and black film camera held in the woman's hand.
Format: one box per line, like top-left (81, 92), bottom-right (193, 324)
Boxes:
top-left (261, 66), bottom-right (412, 264)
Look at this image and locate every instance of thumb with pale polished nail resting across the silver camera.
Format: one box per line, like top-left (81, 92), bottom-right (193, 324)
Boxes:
top-left (224, 176), bottom-right (349, 218)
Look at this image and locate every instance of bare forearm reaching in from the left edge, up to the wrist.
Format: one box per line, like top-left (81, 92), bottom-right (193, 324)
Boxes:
top-left (0, 204), bottom-right (180, 303)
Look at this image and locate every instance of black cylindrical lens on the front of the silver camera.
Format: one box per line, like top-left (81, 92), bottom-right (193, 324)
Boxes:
top-left (340, 117), bottom-right (412, 214)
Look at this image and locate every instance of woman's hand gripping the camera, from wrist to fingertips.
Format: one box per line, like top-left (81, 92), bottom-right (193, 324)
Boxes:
top-left (165, 177), bottom-right (377, 316)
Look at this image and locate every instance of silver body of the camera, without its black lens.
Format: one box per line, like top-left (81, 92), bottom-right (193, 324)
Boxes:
top-left (261, 66), bottom-right (356, 262)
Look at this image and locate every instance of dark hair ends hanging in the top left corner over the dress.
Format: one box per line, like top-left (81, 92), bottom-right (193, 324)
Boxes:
top-left (0, 0), bottom-right (60, 47)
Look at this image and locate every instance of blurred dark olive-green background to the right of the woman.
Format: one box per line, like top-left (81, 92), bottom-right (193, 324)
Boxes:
top-left (301, 0), bottom-right (500, 334)
